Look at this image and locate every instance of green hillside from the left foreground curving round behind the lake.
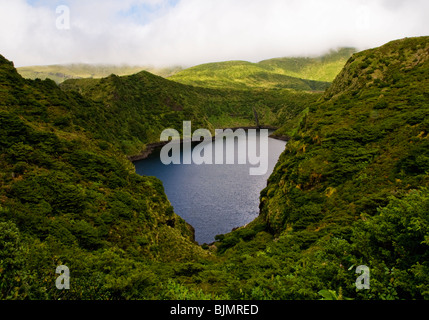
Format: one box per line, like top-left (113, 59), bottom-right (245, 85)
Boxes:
top-left (0, 52), bottom-right (320, 299)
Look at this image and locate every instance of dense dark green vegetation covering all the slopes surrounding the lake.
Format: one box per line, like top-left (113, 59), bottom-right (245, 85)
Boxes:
top-left (0, 37), bottom-right (429, 300)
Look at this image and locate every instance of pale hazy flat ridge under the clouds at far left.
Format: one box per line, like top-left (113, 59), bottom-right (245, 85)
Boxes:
top-left (17, 63), bottom-right (182, 83)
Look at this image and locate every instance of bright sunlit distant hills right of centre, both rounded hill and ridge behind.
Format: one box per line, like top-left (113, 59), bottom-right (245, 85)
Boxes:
top-left (169, 48), bottom-right (356, 91)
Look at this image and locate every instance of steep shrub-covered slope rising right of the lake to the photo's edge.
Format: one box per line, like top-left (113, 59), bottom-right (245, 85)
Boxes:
top-left (211, 37), bottom-right (429, 299)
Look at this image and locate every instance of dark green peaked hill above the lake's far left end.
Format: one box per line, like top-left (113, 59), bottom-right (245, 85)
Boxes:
top-left (60, 71), bottom-right (210, 155)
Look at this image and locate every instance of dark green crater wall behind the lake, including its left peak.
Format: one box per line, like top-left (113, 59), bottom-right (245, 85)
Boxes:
top-left (60, 71), bottom-right (320, 155)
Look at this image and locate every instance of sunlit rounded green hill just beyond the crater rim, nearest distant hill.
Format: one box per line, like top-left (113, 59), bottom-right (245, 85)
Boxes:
top-left (169, 61), bottom-right (329, 91)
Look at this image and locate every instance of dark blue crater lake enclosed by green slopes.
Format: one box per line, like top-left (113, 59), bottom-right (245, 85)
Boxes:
top-left (135, 129), bottom-right (286, 244)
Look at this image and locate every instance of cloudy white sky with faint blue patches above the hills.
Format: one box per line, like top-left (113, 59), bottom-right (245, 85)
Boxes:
top-left (0, 0), bottom-right (429, 67)
